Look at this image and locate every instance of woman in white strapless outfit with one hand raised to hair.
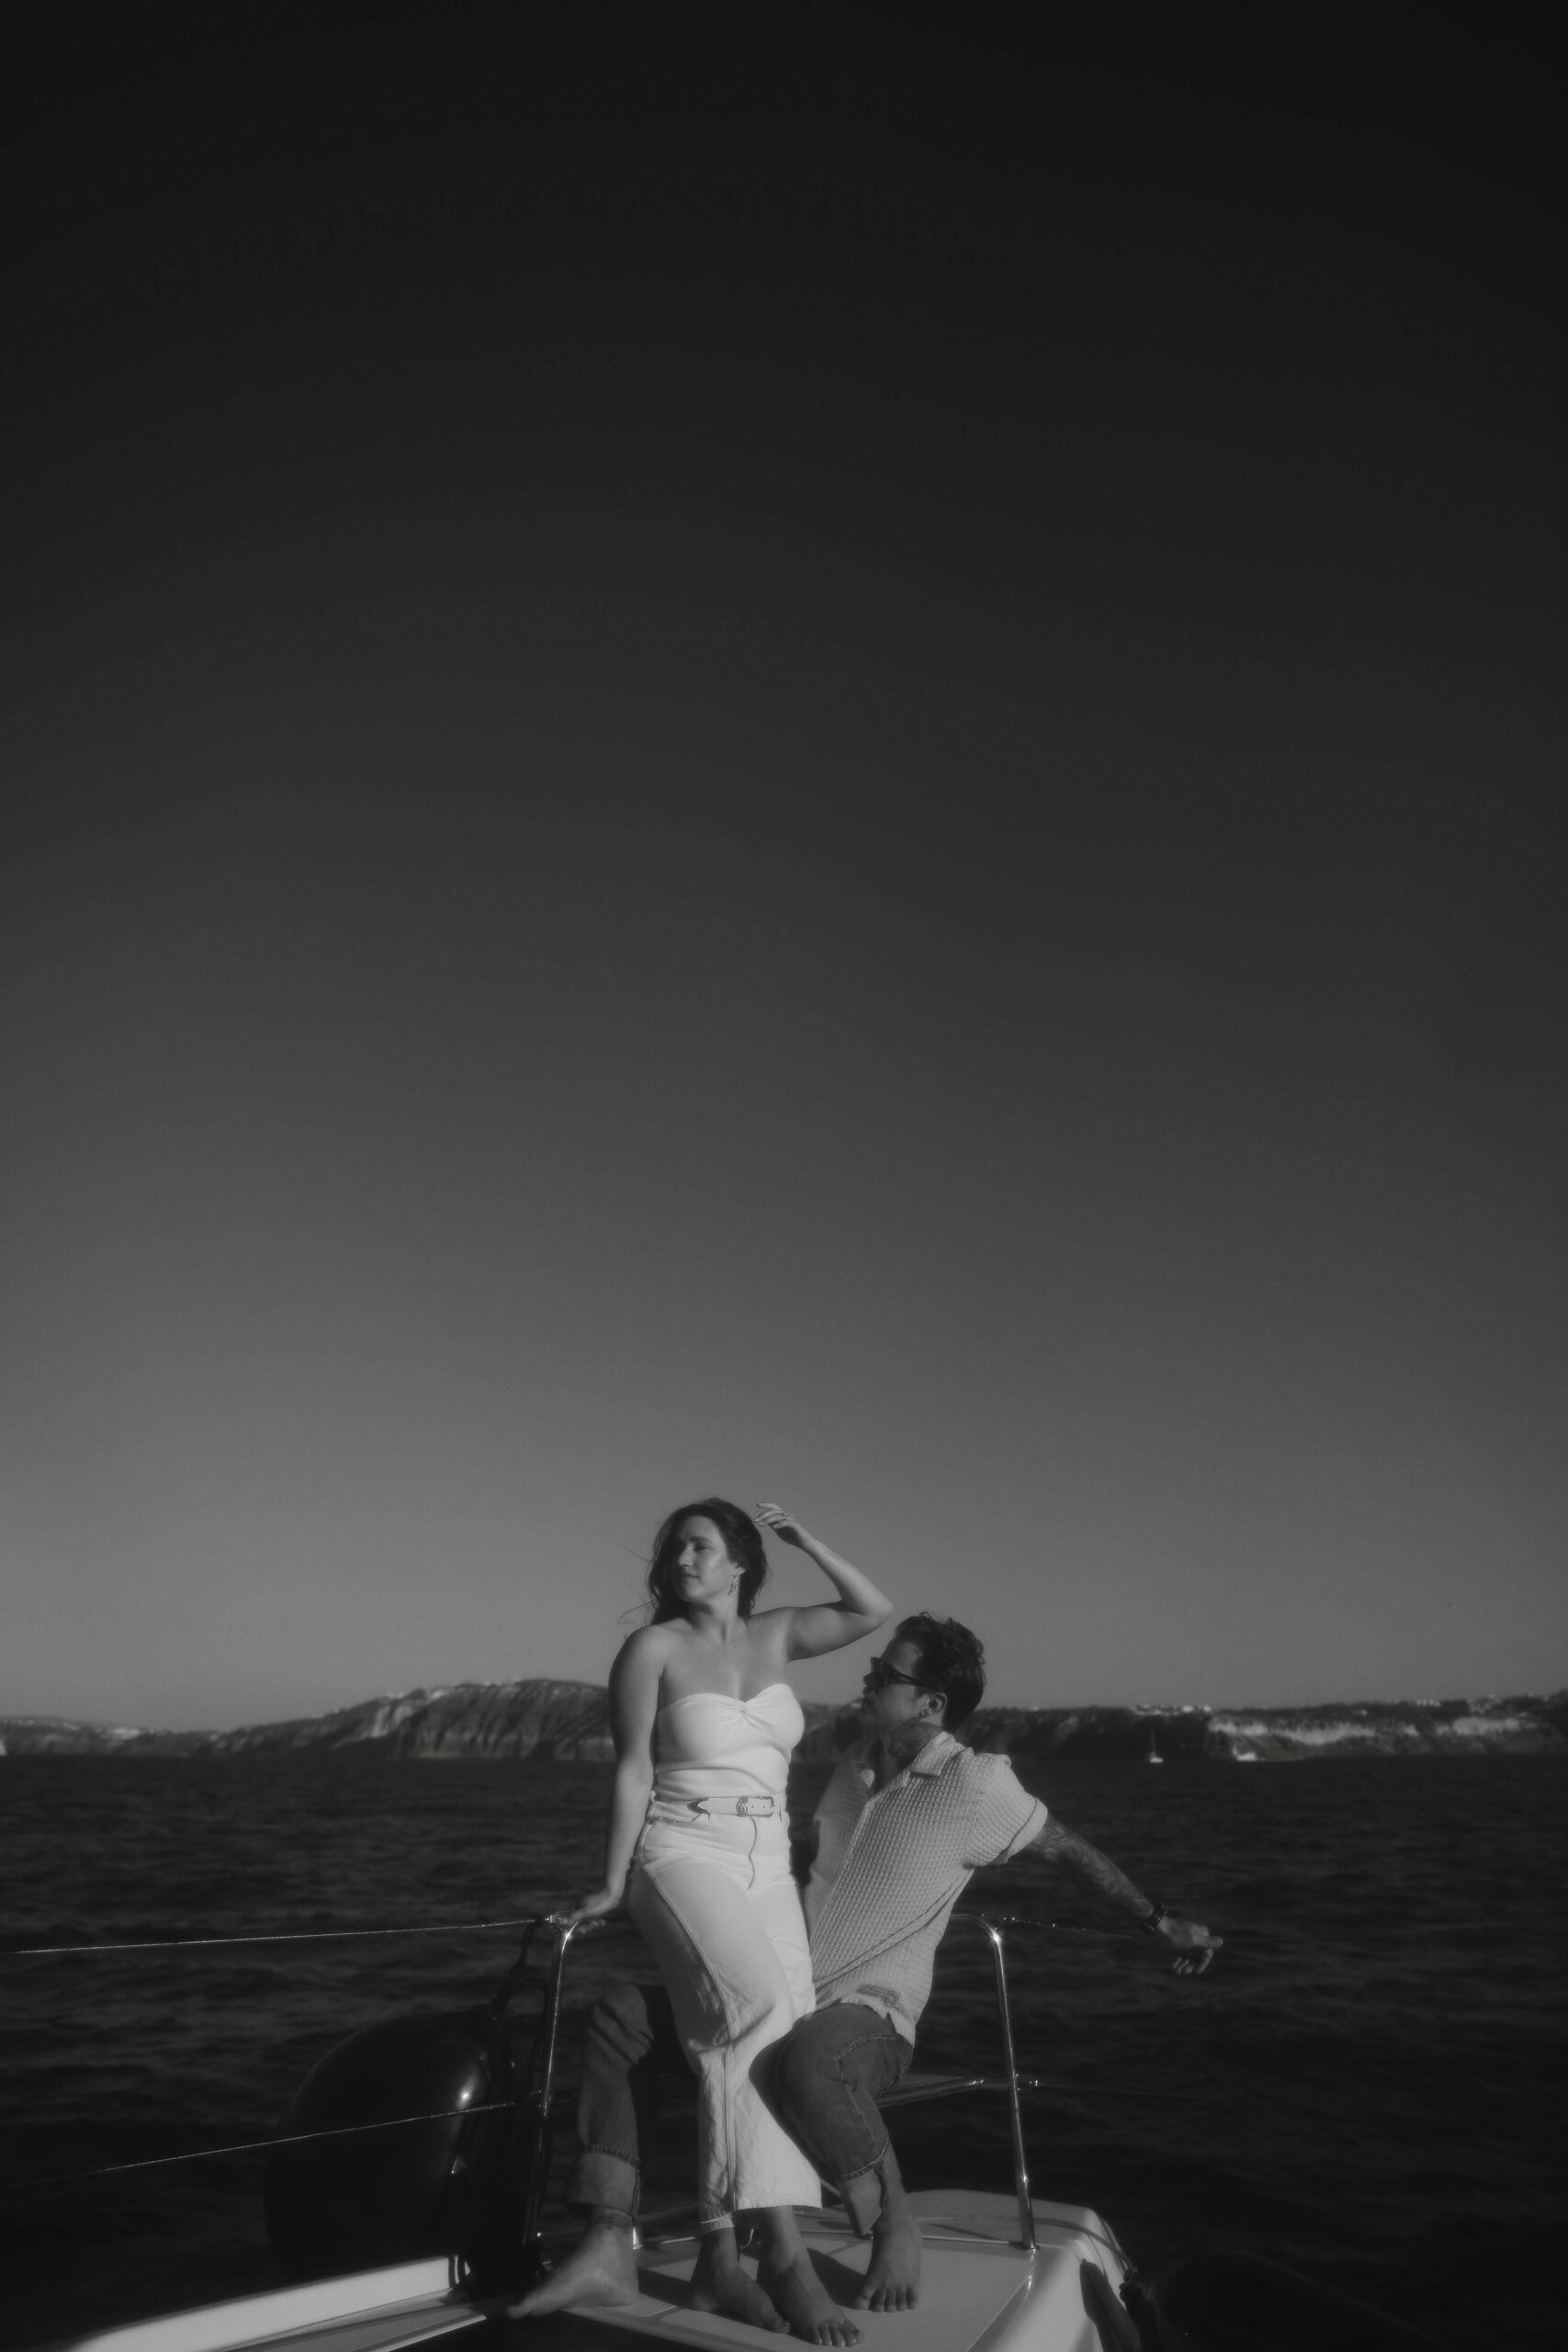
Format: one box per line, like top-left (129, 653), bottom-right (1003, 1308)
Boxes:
top-left (569, 1496), bottom-right (894, 2345)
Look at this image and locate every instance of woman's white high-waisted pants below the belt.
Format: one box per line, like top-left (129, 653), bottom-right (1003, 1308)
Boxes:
top-left (626, 1802), bottom-right (823, 2227)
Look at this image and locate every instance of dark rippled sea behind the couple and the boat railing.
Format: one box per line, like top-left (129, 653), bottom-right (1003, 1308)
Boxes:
top-left (0, 1757), bottom-right (1568, 2352)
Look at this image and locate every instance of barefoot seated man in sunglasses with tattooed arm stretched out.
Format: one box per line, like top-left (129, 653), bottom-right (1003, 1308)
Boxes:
top-left (513, 1616), bottom-right (1220, 2343)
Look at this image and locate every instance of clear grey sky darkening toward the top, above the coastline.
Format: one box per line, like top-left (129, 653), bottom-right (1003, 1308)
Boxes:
top-left (0, 5), bottom-right (1568, 1724)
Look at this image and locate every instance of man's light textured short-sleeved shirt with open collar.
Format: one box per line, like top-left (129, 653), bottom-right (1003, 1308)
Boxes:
top-left (807, 1731), bottom-right (1046, 2041)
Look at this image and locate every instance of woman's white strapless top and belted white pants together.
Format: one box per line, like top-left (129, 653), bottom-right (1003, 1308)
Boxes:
top-left (626, 1681), bottom-right (820, 2227)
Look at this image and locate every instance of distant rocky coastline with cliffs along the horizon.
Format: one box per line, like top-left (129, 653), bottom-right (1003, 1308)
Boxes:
top-left (0, 1681), bottom-right (1568, 1764)
